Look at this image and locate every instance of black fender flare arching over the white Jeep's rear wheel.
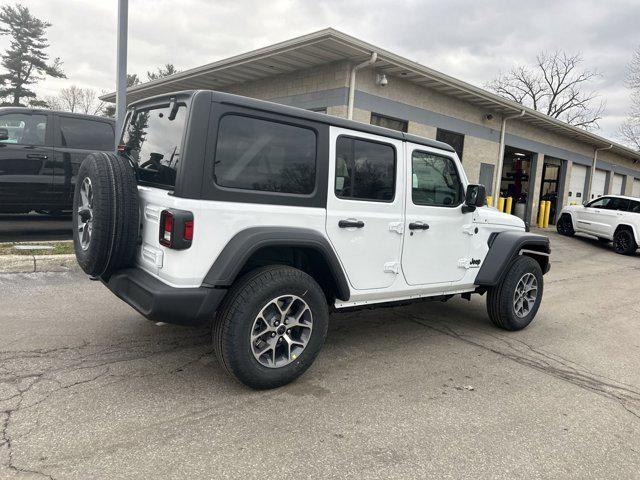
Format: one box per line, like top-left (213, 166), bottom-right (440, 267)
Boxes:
top-left (202, 227), bottom-right (351, 301)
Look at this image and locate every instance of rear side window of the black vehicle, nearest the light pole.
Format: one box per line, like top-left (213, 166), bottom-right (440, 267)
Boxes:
top-left (56, 116), bottom-right (114, 150)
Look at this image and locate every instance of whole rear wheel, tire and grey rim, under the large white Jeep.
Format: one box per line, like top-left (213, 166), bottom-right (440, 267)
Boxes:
top-left (213, 265), bottom-right (329, 389)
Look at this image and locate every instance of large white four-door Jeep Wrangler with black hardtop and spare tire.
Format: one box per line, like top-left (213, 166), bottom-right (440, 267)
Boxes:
top-left (74, 91), bottom-right (550, 388)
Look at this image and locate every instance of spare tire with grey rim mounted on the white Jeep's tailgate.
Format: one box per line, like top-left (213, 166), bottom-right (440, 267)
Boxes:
top-left (73, 153), bottom-right (140, 280)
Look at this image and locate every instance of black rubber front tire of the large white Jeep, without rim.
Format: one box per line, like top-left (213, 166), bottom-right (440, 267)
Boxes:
top-left (487, 255), bottom-right (543, 331)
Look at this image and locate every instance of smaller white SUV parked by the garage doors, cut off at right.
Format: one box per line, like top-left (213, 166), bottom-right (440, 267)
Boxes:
top-left (556, 195), bottom-right (640, 255)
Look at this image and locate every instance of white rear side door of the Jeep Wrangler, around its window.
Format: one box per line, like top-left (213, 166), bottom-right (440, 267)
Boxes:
top-left (325, 127), bottom-right (404, 290)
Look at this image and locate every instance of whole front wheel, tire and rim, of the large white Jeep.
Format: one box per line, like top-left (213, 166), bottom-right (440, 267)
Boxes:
top-left (487, 256), bottom-right (543, 331)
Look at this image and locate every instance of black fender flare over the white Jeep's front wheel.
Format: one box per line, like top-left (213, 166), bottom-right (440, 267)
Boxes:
top-left (475, 230), bottom-right (551, 287)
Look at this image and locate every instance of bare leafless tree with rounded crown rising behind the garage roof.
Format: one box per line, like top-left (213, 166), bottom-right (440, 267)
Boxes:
top-left (486, 51), bottom-right (605, 130)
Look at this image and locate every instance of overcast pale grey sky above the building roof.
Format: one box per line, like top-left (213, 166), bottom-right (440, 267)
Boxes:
top-left (5, 0), bottom-right (640, 138)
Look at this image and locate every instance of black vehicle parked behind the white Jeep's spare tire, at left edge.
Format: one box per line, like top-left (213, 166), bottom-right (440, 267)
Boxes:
top-left (0, 107), bottom-right (114, 214)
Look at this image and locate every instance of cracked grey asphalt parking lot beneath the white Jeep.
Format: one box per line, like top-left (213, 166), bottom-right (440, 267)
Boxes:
top-left (0, 233), bottom-right (640, 479)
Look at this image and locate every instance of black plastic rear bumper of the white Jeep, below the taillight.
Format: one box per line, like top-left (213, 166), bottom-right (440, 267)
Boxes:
top-left (106, 268), bottom-right (227, 325)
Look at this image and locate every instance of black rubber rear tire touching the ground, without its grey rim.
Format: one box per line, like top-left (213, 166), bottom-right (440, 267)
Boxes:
top-left (213, 265), bottom-right (329, 389)
